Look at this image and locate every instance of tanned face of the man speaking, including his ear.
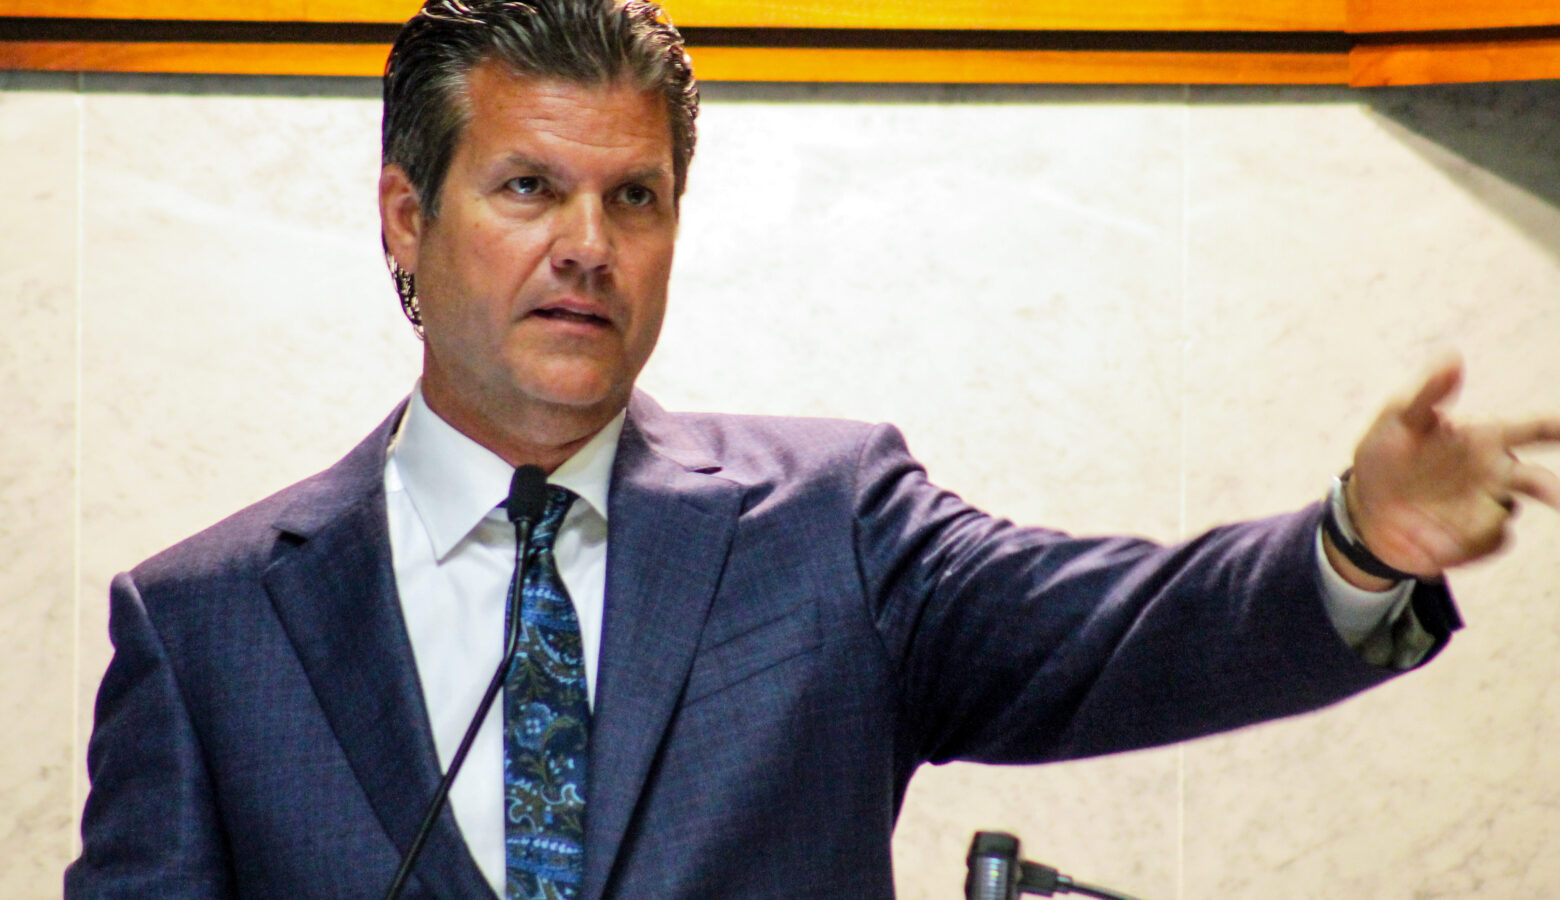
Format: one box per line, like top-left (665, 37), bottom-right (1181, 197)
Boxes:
top-left (381, 62), bottom-right (677, 446)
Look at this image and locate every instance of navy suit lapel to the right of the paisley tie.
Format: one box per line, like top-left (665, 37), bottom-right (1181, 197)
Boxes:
top-left (583, 395), bottom-right (743, 900)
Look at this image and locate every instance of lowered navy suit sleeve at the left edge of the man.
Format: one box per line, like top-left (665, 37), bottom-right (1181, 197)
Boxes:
top-left (66, 574), bottom-right (234, 898)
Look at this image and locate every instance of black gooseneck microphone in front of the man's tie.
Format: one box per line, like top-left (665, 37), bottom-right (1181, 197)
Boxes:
top-left (385, 465), bottom-right (548, 900)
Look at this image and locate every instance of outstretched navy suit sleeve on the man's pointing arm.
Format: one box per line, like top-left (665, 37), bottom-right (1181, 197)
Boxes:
top-left (853, 426), bottom-right (1451, 763)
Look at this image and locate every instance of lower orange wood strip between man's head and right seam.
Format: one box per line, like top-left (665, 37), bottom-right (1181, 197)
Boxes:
top-left (690, 47), bottom-right (1348, 84)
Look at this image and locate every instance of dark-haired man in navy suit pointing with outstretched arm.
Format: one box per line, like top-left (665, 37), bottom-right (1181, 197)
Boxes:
top-left (66, 0), bottom-right (1560, 900)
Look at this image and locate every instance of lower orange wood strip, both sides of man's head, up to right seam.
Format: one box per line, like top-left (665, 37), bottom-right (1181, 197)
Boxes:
top-left (0, 41), bottom-right (1349, 84)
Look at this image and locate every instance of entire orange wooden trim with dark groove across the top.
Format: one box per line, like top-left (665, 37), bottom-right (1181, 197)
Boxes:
top-left (0, 0), bottom-right (1560, 86)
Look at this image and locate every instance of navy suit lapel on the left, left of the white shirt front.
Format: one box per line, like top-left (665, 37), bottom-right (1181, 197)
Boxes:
top-left (264, 410), bottom-right (493, 900)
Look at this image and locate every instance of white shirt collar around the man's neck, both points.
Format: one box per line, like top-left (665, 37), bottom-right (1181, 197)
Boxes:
top-left (390, 381), bottom-right (627, 562)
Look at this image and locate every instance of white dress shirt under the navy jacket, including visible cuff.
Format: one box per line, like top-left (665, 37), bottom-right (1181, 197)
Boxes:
top-left (385, 384), bottom-right (1413, 897)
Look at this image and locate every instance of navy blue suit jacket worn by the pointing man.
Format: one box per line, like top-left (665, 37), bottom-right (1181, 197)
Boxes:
top-left (66, 395), bottom-right (1454, 900)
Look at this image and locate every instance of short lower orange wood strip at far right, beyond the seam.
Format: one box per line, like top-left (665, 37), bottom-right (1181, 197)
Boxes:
top-left (1349, 37), bottom-right (1560, 87)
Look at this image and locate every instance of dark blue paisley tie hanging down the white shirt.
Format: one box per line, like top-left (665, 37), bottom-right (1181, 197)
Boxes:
top-left (504, 485), bottom-right (590, 900)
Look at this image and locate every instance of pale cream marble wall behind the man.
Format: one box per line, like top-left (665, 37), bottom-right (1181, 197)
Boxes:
top-left (0, 73), bottom-right (1560, 900)
